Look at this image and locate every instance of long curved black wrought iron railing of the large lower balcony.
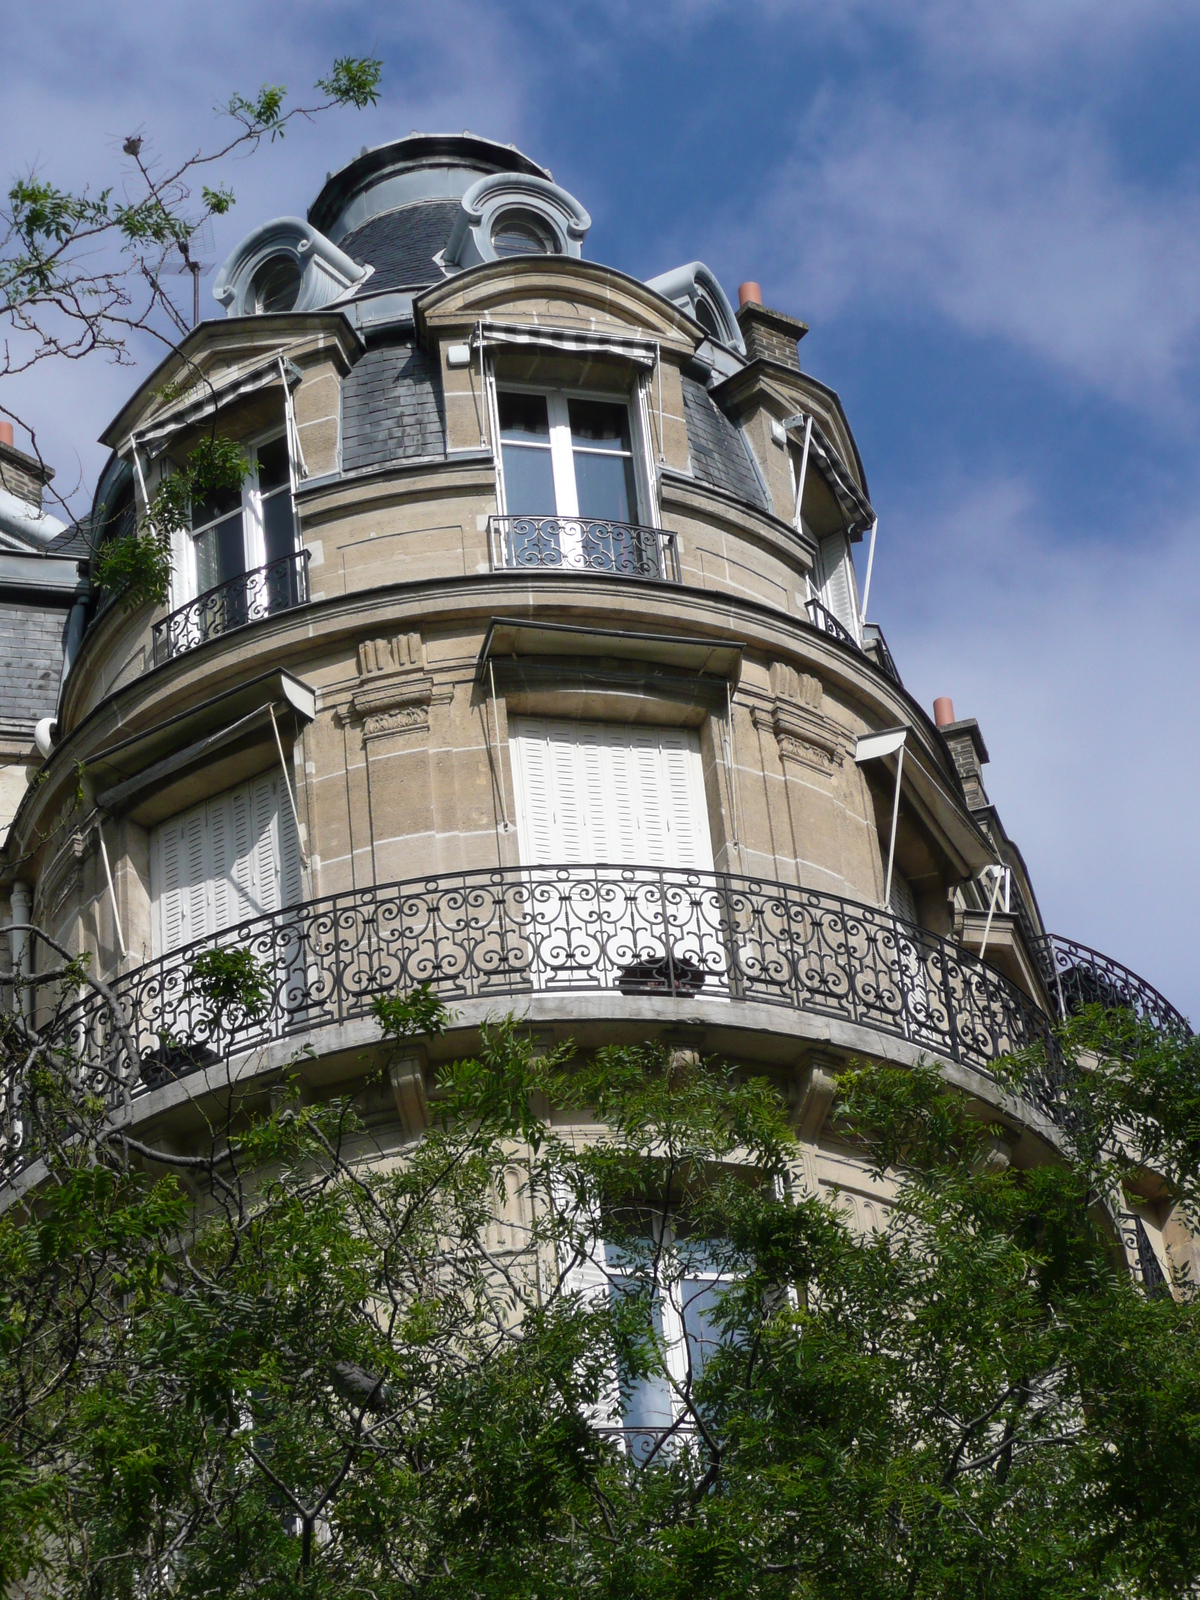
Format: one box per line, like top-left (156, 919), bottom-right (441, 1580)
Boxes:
top-left (18, 866), bottom-right (1054, 1139)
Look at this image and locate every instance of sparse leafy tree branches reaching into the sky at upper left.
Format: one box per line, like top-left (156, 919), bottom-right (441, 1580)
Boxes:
top-left (0, 56), bottom-right (382, 512)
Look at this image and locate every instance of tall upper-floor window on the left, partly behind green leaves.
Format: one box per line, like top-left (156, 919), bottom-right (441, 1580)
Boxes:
top-left (179, 435), bottom-right (296, 604)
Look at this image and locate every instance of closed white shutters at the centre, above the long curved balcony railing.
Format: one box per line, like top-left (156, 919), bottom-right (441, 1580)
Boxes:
top-left (512, 717), bottom-right (712, 872)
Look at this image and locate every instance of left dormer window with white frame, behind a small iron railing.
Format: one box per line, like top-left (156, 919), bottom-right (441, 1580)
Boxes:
top-left (176, 435), bottom-right (299, 611)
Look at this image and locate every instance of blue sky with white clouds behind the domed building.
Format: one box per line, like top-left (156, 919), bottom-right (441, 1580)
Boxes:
top-left (0, 0), bottom-right (1200, 1022)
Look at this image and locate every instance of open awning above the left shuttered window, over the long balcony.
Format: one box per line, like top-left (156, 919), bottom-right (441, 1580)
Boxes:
top-left (86, 669), bottom-right (317, 821)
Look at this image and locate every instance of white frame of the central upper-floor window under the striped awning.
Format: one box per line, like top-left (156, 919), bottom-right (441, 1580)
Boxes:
top-left (488, 377), bottom-right (659, 565)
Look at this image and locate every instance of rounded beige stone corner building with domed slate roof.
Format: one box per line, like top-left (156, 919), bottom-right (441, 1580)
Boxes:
top-left (5, 136), bottom-right (1190, 1299)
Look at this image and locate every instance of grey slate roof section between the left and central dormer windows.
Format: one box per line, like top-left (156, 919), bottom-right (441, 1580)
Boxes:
top-left (342, 332), bottom-right (446, 472)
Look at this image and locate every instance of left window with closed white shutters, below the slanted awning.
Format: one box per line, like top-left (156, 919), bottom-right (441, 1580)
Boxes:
top-left (150, 771), bottom-right (301, 955)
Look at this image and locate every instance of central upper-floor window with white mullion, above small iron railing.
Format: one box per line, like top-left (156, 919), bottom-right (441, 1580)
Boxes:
top-left (498, 390), bottom-right (637, 522)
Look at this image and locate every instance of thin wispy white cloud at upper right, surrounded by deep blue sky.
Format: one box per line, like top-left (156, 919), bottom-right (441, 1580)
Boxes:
top-left (742, 102), bottom-right (1200, 410)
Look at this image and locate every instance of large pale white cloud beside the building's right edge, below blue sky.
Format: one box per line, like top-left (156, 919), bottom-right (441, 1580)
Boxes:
top-left (872, 478), bottom-right (1200, 1021)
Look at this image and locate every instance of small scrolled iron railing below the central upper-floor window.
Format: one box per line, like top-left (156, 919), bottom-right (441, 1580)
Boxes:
top-left (490, 517), bottom-right (680, 582)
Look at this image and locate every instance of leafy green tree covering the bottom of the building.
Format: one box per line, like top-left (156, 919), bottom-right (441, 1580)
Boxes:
top-left (0, 950), bottom-right (1200, 1600)
